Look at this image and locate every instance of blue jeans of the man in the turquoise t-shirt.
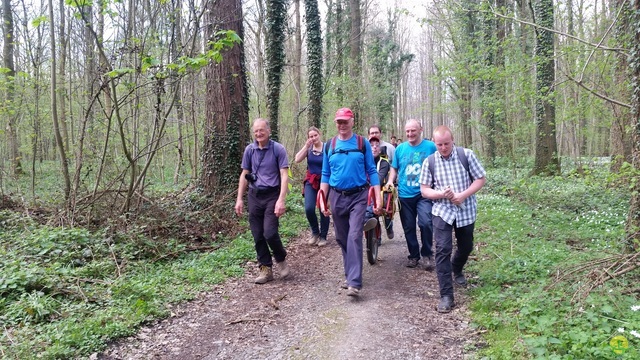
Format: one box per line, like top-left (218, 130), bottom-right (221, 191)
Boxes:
top-left (399, 194), bottom-right (433, 260)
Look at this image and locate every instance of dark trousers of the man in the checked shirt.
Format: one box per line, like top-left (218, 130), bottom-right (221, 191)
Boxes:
top-left (433, 216), bottom-right (475, 299)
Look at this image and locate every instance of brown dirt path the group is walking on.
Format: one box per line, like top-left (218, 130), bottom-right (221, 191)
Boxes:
top-left (99, 216), bottom-right (482, 360)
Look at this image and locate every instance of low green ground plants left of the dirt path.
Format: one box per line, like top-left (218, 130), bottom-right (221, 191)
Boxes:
top-left (0, 189), bottom-right (306, 359)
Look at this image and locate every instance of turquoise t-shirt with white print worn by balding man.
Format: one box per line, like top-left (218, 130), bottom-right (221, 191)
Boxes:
top-left (391, 139), bottom-right (437, 198)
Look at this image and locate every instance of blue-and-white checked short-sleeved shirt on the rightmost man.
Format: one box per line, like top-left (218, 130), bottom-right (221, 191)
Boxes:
top-left (420, 148), bottom-right (486, 228)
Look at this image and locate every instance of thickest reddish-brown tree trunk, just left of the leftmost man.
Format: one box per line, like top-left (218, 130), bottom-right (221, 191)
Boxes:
top-left (200, 0), bottom-right (251, 194)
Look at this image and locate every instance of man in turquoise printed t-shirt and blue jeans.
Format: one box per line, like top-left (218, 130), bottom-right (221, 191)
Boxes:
top-left (387, 119), bottom-right (437, 270)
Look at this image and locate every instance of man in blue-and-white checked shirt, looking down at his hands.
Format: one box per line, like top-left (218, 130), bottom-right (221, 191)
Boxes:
top-left (420, 125), bottom-right (486, 313)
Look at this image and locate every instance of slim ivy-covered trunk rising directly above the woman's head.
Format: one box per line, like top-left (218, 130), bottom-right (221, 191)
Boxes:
top-left (304, 0), bottom-right (323, 128)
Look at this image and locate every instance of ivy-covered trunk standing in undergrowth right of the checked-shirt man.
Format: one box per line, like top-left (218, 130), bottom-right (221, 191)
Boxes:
top-left (532, 0), bottom-right (560, 175)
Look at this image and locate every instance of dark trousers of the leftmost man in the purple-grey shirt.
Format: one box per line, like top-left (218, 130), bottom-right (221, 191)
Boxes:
top-left (247, 189), bottom-right (287, 267)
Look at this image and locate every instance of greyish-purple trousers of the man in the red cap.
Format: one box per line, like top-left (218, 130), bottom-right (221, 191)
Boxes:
top-left (329, 189), bottom-right (368, 289)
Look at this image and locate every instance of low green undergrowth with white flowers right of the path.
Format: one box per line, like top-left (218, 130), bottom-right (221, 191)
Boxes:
top-left (469, 168), bottom-right (640, 359)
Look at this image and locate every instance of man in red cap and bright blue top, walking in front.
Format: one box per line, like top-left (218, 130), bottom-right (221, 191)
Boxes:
top-left (320, 108), bottom-right (382, 296)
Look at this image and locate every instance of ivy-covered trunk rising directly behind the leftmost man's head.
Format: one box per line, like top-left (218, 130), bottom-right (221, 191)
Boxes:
top-left (266, 0), bottom-right (287, 141)
